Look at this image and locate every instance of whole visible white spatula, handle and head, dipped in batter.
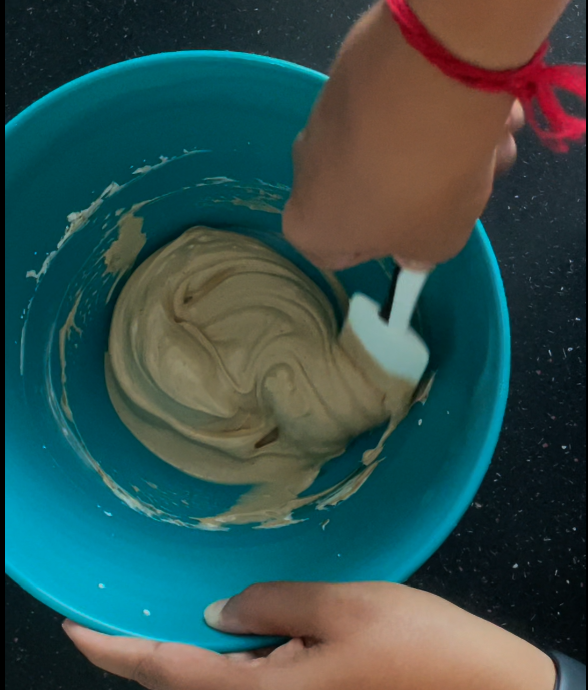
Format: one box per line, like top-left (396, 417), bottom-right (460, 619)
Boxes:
top-left (343, 268), bottom-right (429, 387)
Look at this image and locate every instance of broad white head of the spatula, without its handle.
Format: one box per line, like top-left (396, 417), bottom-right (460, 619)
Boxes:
top-left (344, 294), bottom-right (429, 386)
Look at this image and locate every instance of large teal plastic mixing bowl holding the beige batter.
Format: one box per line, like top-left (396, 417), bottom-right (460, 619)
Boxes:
top-left (5, 52), bottom-right (509, 651)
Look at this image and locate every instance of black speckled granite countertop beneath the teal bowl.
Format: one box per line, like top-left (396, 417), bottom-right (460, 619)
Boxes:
top-left (5, 0), bottom-right (586, 690)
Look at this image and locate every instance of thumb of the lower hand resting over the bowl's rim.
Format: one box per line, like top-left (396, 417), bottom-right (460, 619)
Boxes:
top-left (204, 582), bottom-right (339, 641)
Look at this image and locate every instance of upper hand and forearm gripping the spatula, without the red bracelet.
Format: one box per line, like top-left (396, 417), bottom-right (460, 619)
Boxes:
top-left (283, 0), bottom-right (582, 270)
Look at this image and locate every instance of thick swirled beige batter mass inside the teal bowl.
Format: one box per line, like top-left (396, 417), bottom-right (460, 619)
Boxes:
top-left (106, 228), bottom-right (413, 526)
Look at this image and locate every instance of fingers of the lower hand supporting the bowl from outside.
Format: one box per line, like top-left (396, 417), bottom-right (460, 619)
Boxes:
top-left (63, 621), bottom-right (255, 690)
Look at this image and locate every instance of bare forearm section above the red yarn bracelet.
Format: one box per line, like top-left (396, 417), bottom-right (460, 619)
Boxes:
top-left (409, 0), bottom-right (569, 69)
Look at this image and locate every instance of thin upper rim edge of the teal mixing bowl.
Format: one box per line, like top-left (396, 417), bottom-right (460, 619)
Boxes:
top-left (5, 50), bottom-right (511, 636)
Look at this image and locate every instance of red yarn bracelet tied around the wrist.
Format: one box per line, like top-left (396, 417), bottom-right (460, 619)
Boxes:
top-left (386, 0), bottom-right (586, 152)
